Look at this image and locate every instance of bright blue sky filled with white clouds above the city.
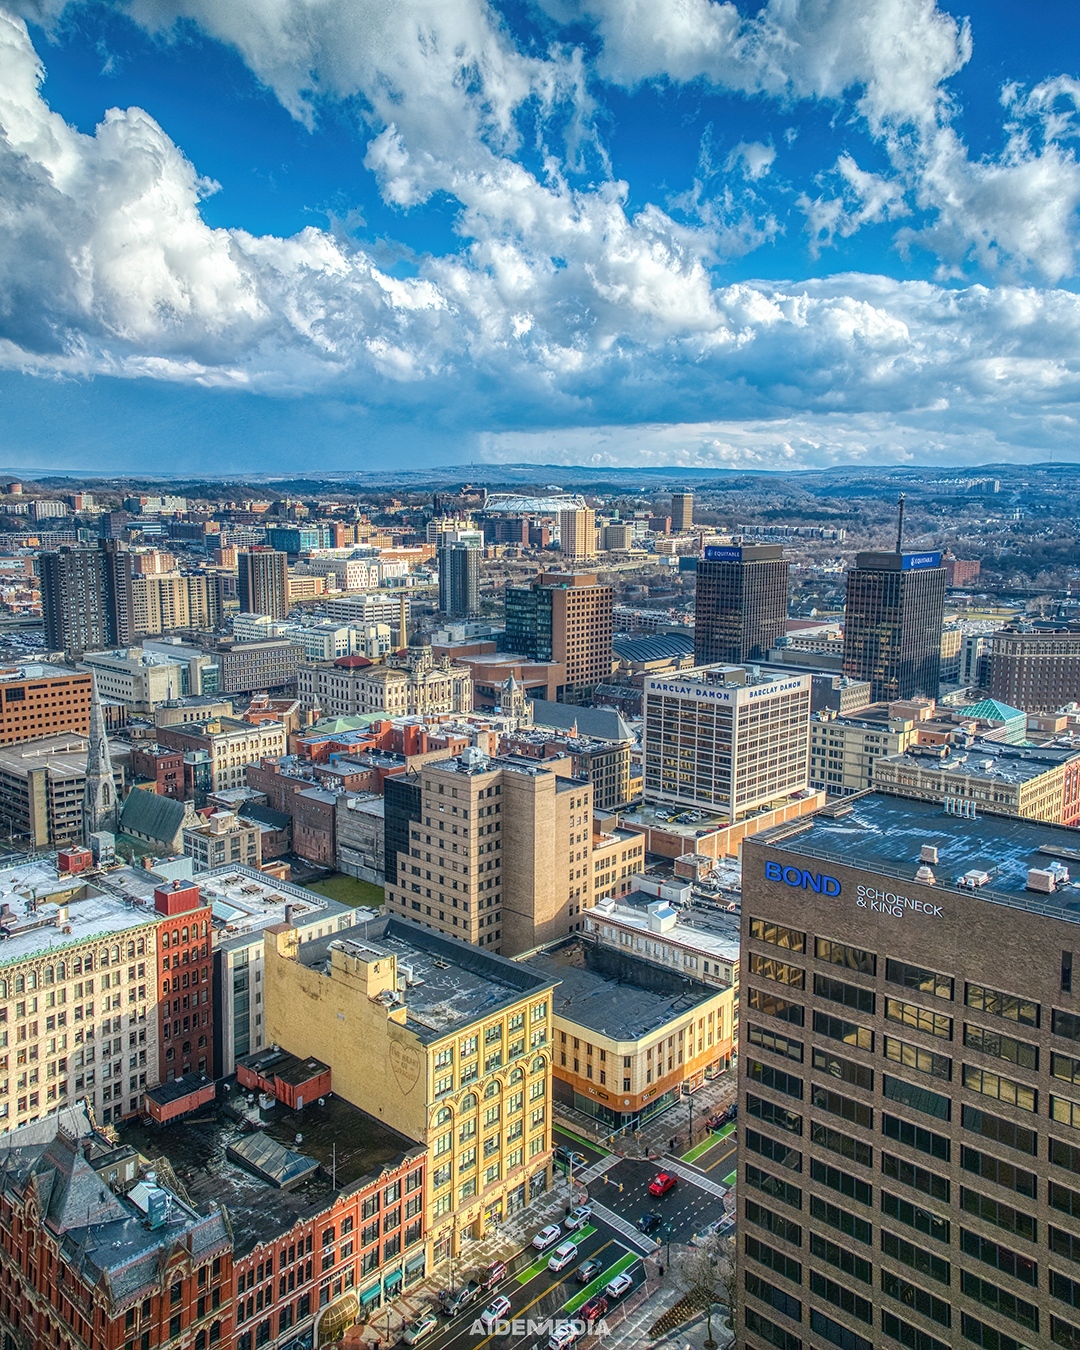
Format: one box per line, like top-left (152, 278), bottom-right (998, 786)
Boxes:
top-left (0, 0), bottom-right (1080, 471)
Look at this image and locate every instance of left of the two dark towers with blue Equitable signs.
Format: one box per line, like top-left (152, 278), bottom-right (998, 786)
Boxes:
top-left (694, 544), bottom-right (788, 666)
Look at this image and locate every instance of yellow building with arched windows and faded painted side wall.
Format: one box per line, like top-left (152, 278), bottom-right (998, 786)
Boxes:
top-left (265, 917), bottom-right (555, 1261)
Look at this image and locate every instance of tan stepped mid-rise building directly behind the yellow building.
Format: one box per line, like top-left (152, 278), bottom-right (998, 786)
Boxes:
top-left (386, 749), bottom-right (593, 954)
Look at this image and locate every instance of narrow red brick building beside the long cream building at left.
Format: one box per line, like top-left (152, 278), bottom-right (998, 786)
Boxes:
top-left (154, 882), bottom-right (213, 1083)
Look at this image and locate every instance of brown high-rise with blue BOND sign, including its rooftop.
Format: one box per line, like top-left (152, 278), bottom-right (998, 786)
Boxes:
top-left (736, 792), bottom-right (1080, 1350)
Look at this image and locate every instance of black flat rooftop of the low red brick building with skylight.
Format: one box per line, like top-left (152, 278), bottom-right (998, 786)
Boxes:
top-left (119, 1080), bottom-right (424, 1257)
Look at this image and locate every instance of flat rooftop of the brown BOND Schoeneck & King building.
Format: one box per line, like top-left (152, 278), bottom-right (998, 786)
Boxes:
top-left (748, 792), bottom-right (1080, 923)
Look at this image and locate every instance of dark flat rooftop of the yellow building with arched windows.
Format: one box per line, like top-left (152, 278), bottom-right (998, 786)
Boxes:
top-left (298, 917), bottom-right (555, 1042)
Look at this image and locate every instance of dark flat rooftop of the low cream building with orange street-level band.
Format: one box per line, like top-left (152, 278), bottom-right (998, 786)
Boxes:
top-left (520, 937), bottom-right (717, 1041)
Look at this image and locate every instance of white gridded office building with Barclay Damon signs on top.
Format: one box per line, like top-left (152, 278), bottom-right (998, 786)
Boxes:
top-left (645, 666), bottom-right (811, 822)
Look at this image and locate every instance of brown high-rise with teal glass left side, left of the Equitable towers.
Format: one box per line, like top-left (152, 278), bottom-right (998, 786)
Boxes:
top-left (506, 572), bottom-right (613, 703)
